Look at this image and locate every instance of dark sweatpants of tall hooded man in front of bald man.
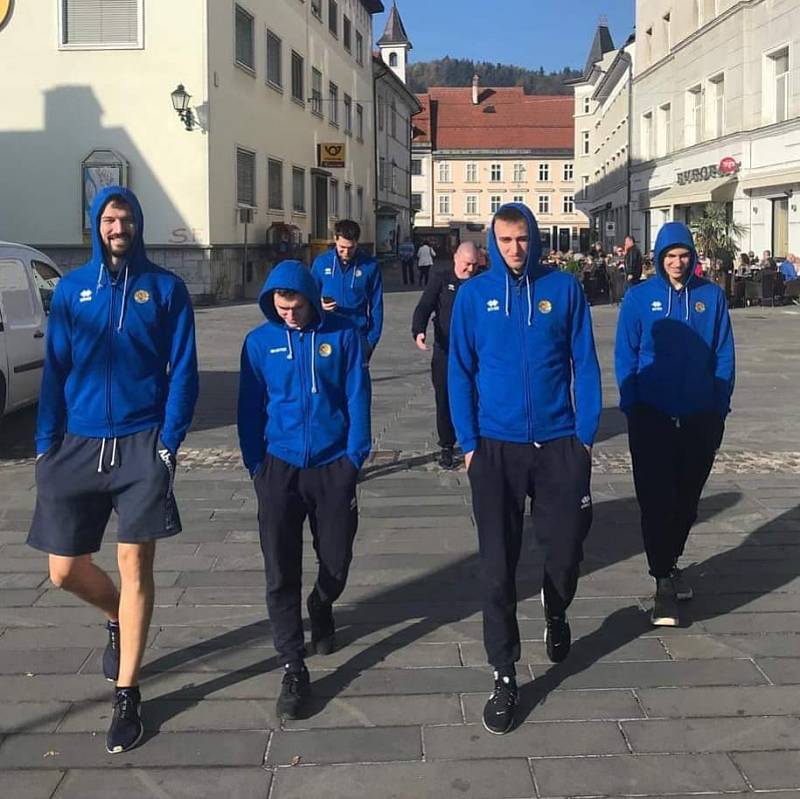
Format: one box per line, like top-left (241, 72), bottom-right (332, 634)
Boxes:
top-left (469, 436), bottom-right (592, 669)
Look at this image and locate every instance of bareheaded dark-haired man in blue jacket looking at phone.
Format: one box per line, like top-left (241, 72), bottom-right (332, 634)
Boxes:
top-left (311, 219), bottom-right (383, 361)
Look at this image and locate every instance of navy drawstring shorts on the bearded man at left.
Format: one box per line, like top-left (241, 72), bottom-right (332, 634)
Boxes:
top-left (28, 427), bottom-right (181, 557)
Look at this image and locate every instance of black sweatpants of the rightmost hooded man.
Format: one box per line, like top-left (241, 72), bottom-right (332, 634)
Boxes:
top-left (628, 405), bottom-right (725, 577)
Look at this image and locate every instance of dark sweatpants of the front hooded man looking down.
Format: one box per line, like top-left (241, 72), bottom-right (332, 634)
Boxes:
top-left (254, 455), bottom-right (358, 665)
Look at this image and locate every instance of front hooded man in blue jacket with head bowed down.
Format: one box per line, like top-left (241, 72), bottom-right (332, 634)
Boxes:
top-left (238, 261), bottom-right (370, 719)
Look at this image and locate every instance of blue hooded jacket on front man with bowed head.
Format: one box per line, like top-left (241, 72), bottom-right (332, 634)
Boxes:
top-left (238, 261), bottom-right (370, 476)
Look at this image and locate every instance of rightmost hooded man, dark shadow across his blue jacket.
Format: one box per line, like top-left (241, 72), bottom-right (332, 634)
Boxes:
top-left (615, 222), bottom-right (735, 626)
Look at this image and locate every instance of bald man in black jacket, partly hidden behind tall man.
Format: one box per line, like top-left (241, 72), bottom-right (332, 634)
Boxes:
top-left (411, 241), bottom-right (480, 469)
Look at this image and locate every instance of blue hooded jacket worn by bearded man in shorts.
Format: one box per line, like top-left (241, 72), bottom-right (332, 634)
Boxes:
top-left (36, 186), bottom-right (198, 454)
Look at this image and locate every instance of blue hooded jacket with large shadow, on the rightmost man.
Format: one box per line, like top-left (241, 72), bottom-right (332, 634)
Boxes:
top-left (614, 222), bottom-right (735, 418)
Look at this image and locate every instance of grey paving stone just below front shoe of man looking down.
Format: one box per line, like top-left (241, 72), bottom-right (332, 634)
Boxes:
top-left (268, 727), bottom-right (422, 766)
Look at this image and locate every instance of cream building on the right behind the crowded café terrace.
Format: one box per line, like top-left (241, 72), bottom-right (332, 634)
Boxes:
top-left (631, 0), bottom-right (800, 256)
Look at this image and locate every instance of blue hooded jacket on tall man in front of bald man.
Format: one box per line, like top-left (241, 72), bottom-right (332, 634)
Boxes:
top-left (448, 203), bottom-right (602, 452)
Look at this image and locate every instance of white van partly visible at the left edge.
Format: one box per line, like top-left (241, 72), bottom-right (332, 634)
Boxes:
top-left (0, 241), bottom-right (61, 416)
